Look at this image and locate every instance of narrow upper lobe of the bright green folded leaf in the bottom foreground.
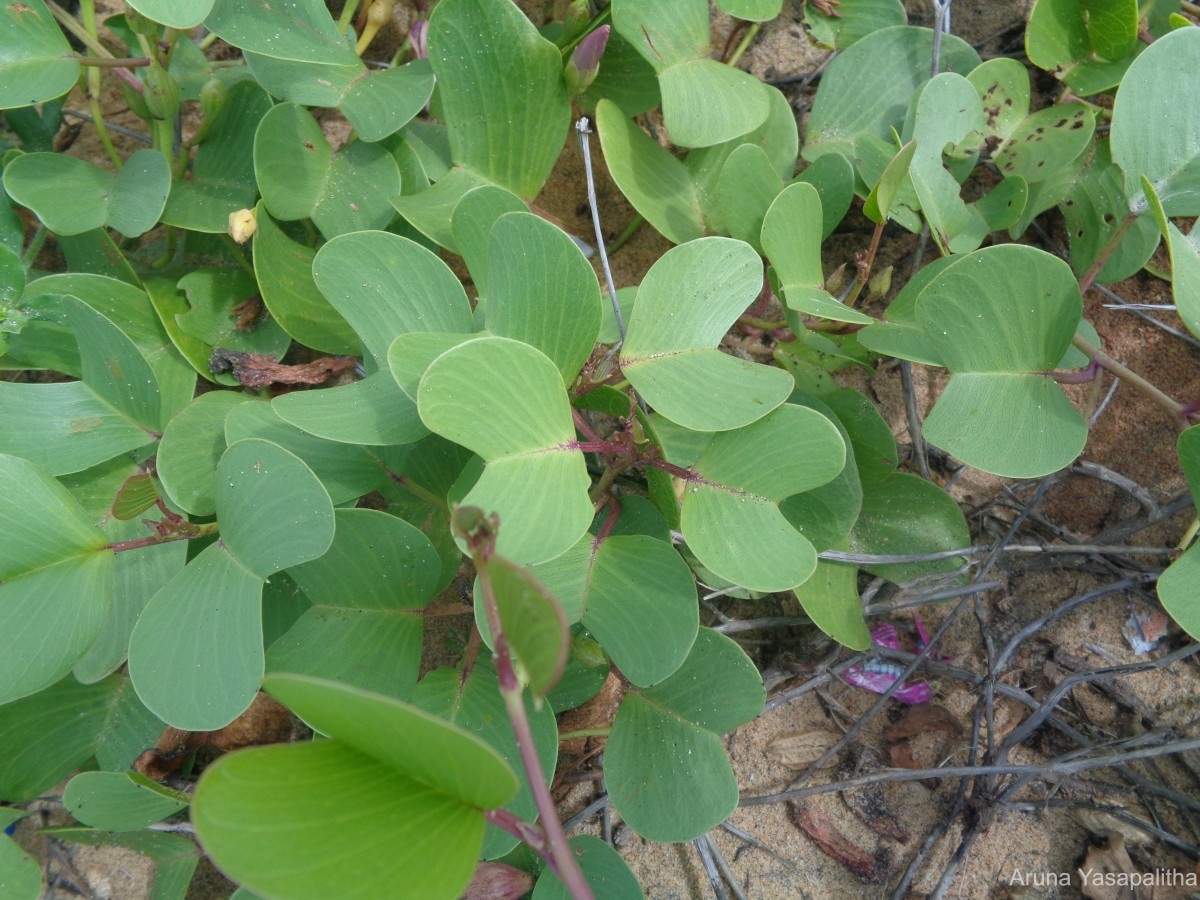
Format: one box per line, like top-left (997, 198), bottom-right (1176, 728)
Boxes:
top-left (263, 673), bottom-right (517, 809)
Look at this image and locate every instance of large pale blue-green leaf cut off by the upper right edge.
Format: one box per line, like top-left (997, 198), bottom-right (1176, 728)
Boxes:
top-left (1112, 28), bottom-right (1200, 216)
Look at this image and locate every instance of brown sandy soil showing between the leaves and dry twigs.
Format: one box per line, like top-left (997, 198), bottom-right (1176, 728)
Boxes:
top-left (11, 0), bottom-right (1200, 900)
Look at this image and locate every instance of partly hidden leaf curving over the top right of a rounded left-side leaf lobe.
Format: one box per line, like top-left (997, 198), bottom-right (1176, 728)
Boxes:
top-left (226, 402), bottom-right (386, 505)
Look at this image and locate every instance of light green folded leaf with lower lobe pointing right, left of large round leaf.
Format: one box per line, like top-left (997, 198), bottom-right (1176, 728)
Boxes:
top-left (762, 181), bottom-right (875, 325)
